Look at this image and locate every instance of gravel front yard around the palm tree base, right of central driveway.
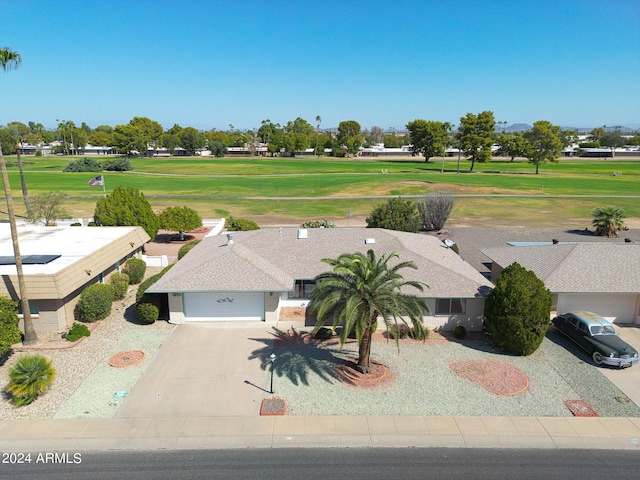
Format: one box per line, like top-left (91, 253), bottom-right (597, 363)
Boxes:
top-left (274, 330), bottom-right (640, 417)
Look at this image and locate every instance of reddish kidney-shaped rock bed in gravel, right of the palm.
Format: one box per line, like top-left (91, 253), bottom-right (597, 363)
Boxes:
top-left (449, 360), bottom-right (529, 396)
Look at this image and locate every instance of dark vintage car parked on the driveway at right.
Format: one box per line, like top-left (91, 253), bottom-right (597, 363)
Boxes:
top-left (551, 312), bottom-right (638, 367)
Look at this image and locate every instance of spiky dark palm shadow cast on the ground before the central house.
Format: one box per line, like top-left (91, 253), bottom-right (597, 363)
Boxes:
top-left (249, 327), bottom-right (348, 385)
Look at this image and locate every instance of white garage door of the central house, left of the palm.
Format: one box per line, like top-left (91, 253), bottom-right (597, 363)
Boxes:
top-left (184, 292), bottom-right (264, 322)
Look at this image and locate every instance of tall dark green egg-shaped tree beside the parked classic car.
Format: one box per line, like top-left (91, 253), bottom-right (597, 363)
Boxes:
top-left (484, 263), bottom-right (552, 355)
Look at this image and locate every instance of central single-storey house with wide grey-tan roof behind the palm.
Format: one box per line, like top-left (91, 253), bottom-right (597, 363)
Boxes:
top-left (147, 228), bottom-right (492, 330)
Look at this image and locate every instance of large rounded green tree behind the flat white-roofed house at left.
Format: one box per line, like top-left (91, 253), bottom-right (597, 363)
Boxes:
top-left (93, 186), bottom-right (160, 240)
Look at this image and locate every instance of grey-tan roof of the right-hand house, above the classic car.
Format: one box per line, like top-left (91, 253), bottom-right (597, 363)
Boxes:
top-left (482, 242), bottom-right (640, 293)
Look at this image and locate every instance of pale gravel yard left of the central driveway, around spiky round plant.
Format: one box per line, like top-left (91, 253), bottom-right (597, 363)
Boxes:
top-left (0, 269), bottom-right (175, 419)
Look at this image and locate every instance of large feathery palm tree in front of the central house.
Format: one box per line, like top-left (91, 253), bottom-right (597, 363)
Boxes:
top-left (310, 250), bottom-right (428, 373)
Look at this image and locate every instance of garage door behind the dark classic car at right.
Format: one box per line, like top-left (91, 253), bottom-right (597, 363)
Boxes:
top-left (558, 293), bottom-right (636, 323)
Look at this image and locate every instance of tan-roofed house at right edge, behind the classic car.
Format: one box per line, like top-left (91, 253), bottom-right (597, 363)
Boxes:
top-left (482, 242), bottom-right (640, 324)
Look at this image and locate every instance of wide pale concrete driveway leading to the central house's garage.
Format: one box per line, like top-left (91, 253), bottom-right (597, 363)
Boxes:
top-left (116, 322), bottom-right (274, 418)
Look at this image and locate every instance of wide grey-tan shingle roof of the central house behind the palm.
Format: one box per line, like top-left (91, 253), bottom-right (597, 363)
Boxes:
top-left (149, 228), bottom-right (492, 298)
